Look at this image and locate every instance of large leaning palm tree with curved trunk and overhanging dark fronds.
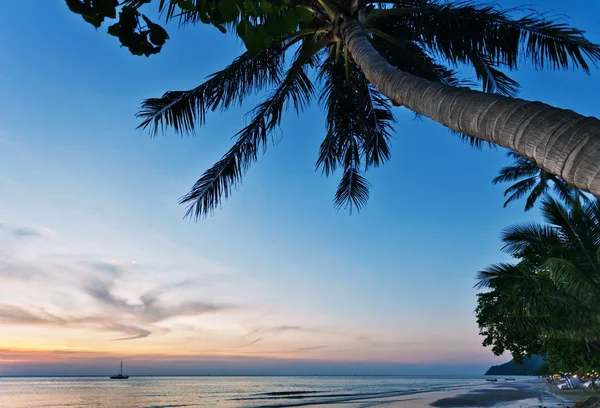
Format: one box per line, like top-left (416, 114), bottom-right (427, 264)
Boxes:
top-left (88, 0), bottom-right (600, 217)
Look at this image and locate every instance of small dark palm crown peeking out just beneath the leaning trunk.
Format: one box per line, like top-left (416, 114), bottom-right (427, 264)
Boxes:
top-left (492, 152), bottom-right (588, 211)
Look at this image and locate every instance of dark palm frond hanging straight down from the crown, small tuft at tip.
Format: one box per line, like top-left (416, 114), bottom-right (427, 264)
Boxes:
top-left (317, 49), bottom-right (394, 212)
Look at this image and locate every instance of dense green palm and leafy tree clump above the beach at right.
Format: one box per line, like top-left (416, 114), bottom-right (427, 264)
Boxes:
top-left (475, 197), bottom-right (600, 351)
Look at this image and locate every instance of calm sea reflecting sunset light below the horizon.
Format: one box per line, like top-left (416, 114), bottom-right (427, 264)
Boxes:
top-left (0, 376), bottom-right (568, 408)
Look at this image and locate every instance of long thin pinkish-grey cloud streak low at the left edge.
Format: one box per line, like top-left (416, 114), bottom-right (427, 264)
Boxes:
top-left (0, 304), bottom-right (152, 340)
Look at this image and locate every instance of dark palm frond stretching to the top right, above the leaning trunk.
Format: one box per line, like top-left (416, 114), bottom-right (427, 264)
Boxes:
top-left (396, 0), bottom-right (600, 71)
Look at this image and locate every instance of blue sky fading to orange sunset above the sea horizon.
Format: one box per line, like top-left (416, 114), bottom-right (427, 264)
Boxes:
top-left (0, 0), bottom-right (600, 375)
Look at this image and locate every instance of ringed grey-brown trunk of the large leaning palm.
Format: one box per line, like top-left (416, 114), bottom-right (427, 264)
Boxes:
top-left (341, 19), bottom-right (600, 198)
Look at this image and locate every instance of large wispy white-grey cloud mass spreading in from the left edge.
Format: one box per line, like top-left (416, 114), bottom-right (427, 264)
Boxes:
top-left (0, 228), bottom-right (233, 341)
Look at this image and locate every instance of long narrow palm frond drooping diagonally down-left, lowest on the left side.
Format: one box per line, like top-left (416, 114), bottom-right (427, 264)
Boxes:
top-left (179, 35), bottom-right (326, 219)
